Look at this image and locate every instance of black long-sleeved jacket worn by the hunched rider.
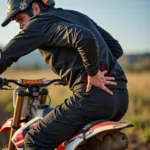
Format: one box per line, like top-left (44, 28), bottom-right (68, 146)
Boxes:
top-left (0, 7), bottom-right (126, 89)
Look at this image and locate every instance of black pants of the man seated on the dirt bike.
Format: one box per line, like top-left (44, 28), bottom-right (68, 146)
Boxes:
top-left (25, 87), bottom-right (128, 150)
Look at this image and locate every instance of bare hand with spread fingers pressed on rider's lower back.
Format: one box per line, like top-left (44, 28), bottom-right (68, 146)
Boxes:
top-left (86, 70), bottom-right (117, 95)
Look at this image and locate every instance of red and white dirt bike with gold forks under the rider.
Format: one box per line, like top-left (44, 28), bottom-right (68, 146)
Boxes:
top-left (0, 78), bottom-right (133, 150)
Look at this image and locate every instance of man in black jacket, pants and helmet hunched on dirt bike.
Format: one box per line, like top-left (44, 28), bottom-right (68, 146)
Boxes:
top-left (0, 0), bottom-right (128, 150)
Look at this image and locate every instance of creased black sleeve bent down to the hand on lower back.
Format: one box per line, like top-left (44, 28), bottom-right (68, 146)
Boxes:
top-left (45, 22), bottom-right (99, 76)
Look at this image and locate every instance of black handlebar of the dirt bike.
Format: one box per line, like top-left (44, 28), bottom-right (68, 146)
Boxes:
top-left (0, 78), bottom-right (67, 87)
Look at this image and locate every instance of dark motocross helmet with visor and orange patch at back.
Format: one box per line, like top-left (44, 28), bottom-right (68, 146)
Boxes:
top-left (2, 0), bottom-right (55, 27)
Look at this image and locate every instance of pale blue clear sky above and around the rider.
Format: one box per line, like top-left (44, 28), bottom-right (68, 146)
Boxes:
top-left (0, 0), bottom-right (150, 54)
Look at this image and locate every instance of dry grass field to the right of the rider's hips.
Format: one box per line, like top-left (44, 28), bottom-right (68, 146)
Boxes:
top-left (124, 72), bottom-right (150, 142)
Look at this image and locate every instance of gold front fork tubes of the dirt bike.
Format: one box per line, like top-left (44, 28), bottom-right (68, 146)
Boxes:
top-left (8, 89), bottom-right (48, 150)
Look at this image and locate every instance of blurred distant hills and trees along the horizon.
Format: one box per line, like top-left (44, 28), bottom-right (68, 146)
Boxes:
top-left (12, 53), bottom-right (150, 72)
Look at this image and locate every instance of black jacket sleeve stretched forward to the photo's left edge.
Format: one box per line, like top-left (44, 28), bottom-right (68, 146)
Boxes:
top-left (0, 21), bottom-right (47, 74)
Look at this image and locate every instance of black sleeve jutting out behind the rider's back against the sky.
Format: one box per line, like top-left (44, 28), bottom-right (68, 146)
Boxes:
top-left (93, 22), bottom-right (123, 59)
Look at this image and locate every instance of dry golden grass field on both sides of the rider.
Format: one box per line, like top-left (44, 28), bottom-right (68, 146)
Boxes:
top-left (0, 70), bottom-right (150, 150)
